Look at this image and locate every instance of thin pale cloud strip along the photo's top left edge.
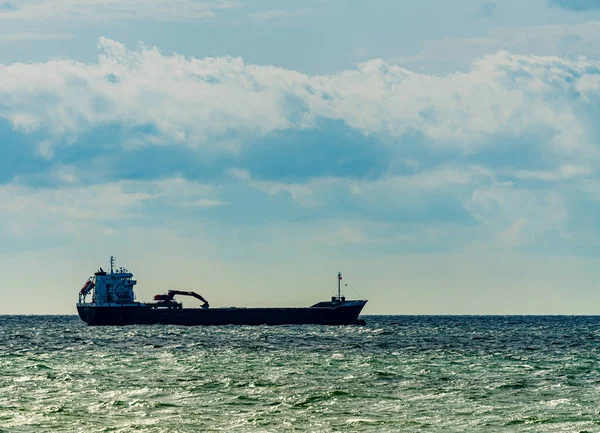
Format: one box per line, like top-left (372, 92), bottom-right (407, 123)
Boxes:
top-left (0, 0), bottom-right (241, 22)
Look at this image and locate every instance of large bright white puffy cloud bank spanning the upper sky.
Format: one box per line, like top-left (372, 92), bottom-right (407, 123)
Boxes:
top-left (0, 38), bottom-right (600, 160)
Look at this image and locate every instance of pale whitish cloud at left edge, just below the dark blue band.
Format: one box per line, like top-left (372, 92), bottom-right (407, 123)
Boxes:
top-left (0, 175), bottom-right (219, 236)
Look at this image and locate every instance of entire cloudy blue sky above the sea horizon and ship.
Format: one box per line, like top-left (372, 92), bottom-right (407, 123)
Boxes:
top-left (0, 0), bottom-right (600, 314)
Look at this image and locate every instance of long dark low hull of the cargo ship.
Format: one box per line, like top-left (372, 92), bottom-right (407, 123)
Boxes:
top-left (77, 301), bottom-right (366, 326)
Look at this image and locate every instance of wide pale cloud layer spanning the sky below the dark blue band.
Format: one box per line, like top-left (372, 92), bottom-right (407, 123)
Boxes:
top-left (0, 158), bottom-right (598, 254)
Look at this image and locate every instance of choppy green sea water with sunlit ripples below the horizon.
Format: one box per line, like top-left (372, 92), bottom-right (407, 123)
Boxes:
top-left (0, 316), bottom-right (600, 432)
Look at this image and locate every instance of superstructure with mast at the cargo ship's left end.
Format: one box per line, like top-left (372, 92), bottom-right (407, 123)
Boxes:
top-left (78, 256), bottom-right (137, 306)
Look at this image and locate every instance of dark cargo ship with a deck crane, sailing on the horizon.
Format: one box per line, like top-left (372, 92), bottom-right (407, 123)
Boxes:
top-left (77, 256), bottom-right (367, 326)
